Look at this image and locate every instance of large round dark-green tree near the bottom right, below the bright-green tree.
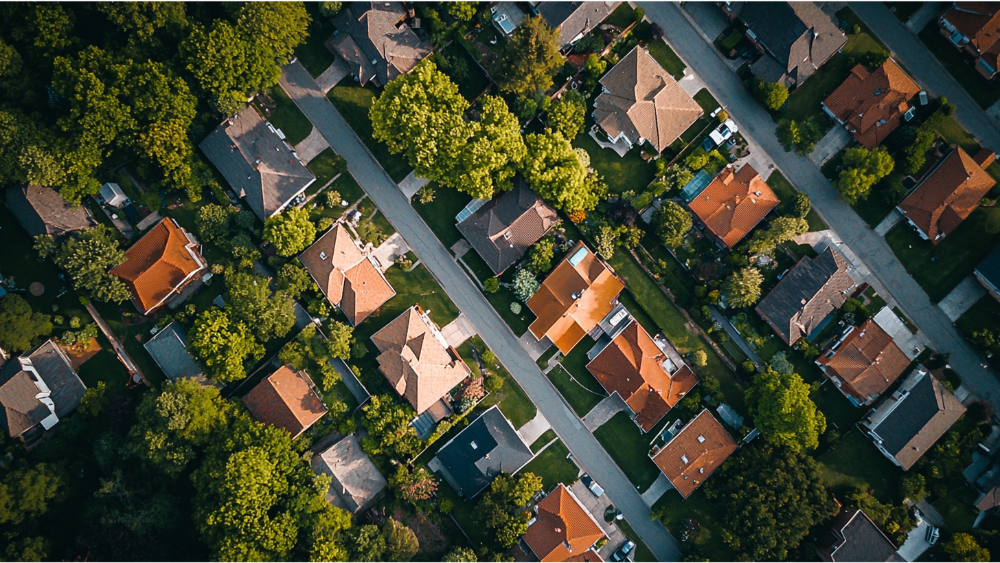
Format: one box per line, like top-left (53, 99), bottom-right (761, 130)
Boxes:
top-left (705, 444), bottom-right (837, 561)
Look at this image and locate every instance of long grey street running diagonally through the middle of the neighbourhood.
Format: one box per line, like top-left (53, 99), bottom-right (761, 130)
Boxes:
top-left (281, 59), bottom-right (680, 562)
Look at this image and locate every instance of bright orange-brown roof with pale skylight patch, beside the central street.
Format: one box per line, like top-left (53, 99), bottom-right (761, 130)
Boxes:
top-left (527, 242), bottom-right (625, 354)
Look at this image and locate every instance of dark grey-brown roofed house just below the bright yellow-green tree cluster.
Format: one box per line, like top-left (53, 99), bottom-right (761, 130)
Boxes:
top-left (458, 175), bottom-right (559, 276)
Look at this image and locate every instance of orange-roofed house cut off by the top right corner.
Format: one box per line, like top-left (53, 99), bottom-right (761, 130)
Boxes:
top-left (938, 0), bottom-right (1000, 80)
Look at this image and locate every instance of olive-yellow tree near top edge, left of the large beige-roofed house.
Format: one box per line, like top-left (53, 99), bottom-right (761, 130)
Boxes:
top-left (490, 16), bottom-right (564, 96)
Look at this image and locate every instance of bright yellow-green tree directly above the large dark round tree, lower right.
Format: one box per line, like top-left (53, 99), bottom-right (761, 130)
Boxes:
top-left (746, 369), bottom-right (826, 451)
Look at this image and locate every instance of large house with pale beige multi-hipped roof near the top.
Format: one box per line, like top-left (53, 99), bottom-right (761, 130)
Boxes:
top-left (592, 45), bottom-right (705, 153)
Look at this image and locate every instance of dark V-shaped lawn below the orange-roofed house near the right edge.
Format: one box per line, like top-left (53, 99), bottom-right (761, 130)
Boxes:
top-left (885, 207), bottom-right (1000, 303)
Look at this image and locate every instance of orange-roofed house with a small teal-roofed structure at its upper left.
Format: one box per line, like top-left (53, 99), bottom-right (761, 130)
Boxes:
top-left (688, 164), bottom-right (781, 249)
